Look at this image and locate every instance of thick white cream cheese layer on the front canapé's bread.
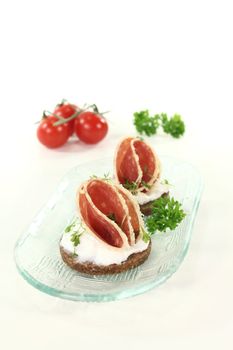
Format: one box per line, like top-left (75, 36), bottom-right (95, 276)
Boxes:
top-left (60, 219), bottom-right (149, 266)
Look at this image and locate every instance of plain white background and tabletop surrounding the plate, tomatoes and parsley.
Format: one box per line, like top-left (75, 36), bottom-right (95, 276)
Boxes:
top-left (0, 0), bottom-right (233, 350)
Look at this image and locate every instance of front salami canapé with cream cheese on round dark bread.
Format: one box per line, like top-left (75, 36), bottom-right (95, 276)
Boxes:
top-left (60, 178), bottom-right (151, 275)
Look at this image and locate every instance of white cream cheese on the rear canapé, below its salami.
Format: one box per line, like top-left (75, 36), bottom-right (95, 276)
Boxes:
top-left (135, 181), bottom-right (169, 205)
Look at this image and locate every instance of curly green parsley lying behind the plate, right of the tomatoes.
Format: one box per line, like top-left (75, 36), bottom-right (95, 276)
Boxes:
top-left (134, 110), bottom-right (185, 138)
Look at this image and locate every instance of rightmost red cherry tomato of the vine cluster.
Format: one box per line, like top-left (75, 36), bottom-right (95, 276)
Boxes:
top-left (74, 111), bottom-right (108, 143)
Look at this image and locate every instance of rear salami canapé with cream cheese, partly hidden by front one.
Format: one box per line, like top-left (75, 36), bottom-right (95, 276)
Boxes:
top-left (114, 137), bottom-right (169, 215)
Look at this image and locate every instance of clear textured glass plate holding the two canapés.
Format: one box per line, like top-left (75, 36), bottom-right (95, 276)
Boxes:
top-left (15, 157), bottom-right (203, 301)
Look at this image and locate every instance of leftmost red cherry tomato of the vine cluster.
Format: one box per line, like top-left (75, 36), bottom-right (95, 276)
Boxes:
top-left (37, 116), bottom-right (70, 148)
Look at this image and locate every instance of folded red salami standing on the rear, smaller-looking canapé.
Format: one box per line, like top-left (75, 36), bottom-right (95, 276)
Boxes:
top-left (115, 137), bottom-right (160, 191)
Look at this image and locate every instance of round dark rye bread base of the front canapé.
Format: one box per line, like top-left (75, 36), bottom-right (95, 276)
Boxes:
top-left (60, 241), bottom-right (151, 275)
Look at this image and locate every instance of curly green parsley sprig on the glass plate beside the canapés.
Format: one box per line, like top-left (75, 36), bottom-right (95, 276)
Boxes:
top-left (146, 197), bottom-right (186, 234)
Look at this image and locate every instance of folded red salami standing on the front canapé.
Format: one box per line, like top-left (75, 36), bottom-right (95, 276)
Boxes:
top-left (78, 179), bottom-right (143, 248)
